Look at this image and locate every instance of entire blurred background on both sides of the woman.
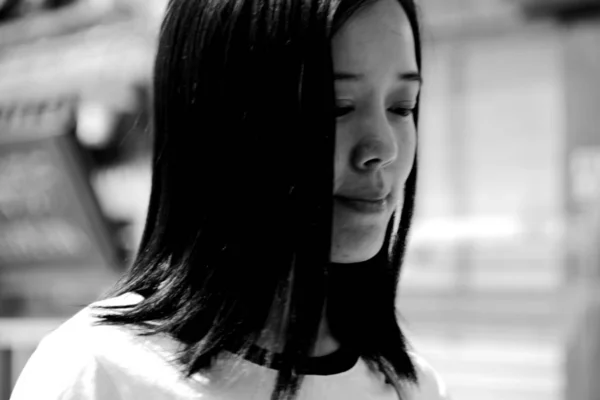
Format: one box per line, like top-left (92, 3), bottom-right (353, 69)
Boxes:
top-left (0, 0), bottom-right (600, 400)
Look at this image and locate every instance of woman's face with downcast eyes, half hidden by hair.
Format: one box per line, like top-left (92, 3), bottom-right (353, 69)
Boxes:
top-left (331, 0), bottom-right (420, 263)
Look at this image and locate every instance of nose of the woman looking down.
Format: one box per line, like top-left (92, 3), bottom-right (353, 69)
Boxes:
top-left (352, 111), bottom-right (398, 171)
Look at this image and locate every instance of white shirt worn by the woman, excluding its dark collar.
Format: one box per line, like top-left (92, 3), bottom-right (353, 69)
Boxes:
top-left (10, 294), bottom-right (447, 400)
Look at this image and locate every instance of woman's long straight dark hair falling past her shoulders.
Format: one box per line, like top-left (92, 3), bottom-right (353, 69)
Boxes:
top-left (95, 0), bottom-right (421, 399)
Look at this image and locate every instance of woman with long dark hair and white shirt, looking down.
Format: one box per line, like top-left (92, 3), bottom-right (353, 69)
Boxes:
top-left (12, 0), bottom-right (444, 400)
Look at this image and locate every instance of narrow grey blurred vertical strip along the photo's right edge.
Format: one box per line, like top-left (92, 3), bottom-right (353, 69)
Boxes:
top-left (563, 15), bottom-right (600, 400)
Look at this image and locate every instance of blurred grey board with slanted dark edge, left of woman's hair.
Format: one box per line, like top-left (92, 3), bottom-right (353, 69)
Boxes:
top-left (0, 99), bottom-right (116, 268)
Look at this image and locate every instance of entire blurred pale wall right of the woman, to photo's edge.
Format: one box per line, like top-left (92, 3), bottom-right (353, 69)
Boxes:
top-left (398, 1), bottom-right (600, 400)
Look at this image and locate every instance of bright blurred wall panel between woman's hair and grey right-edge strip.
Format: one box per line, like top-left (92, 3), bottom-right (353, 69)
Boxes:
top-left (398, 23), bottom-right (565, 400)
